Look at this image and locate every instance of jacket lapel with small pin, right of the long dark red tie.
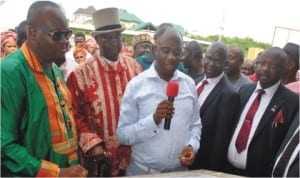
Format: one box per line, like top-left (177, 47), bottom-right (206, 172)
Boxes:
top-left (253, 85), bottom-right (284, 139)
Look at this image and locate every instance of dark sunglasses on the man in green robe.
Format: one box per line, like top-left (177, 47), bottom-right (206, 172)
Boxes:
top-left (29, 24), bottom-right (72, 41)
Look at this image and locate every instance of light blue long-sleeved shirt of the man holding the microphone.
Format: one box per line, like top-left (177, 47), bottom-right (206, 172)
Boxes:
top-left (117, 62), bottom-right (202, 171)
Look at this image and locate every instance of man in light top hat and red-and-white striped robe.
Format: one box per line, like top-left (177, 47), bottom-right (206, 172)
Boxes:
top-left (67, 8), bottom-right (142, 176)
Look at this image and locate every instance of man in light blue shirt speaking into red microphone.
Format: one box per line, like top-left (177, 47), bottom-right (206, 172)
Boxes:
top-left (117, 24), bottom-right (202, 176)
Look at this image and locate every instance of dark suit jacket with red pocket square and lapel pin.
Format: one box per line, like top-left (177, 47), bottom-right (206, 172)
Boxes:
top-left (235, 84), bottom-right (299, 177)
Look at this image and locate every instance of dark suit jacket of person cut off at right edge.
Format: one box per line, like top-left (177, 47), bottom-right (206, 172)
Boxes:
top-left (273, 112), bottom-right (299, 177)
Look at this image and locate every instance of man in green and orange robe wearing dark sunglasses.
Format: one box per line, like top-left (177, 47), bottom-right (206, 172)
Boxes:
top-left (0, 1), bottom-right (87, 177)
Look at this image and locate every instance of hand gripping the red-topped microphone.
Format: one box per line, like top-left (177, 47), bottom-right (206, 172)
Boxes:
top-left (153, 100), bottom-right (174, 125)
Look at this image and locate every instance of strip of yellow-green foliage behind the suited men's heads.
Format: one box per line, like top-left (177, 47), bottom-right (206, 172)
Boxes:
top-left (191, 35), bottom-right (271, 54)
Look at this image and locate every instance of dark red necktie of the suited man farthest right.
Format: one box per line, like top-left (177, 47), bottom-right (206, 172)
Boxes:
top-left (235, 89), bottom-right (265, 153)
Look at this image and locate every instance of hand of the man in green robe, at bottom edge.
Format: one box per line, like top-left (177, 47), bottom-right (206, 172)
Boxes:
top-left (58, 164), bottom-right (88, 177)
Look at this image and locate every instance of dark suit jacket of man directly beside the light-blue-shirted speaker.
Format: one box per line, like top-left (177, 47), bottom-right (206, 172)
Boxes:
top-left (190, 76), bottom-right (240, 171)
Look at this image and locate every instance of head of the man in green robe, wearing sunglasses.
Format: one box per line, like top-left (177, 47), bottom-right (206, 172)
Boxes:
top-left (26, 1), bottom-right (71, 68)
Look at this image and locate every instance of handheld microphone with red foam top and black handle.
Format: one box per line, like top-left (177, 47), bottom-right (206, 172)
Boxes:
top-left (164, 80), bottom-right (179, 130)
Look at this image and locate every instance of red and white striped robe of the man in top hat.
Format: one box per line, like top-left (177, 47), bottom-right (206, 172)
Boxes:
top-left (67, 52), bottom-right (142, 176)
